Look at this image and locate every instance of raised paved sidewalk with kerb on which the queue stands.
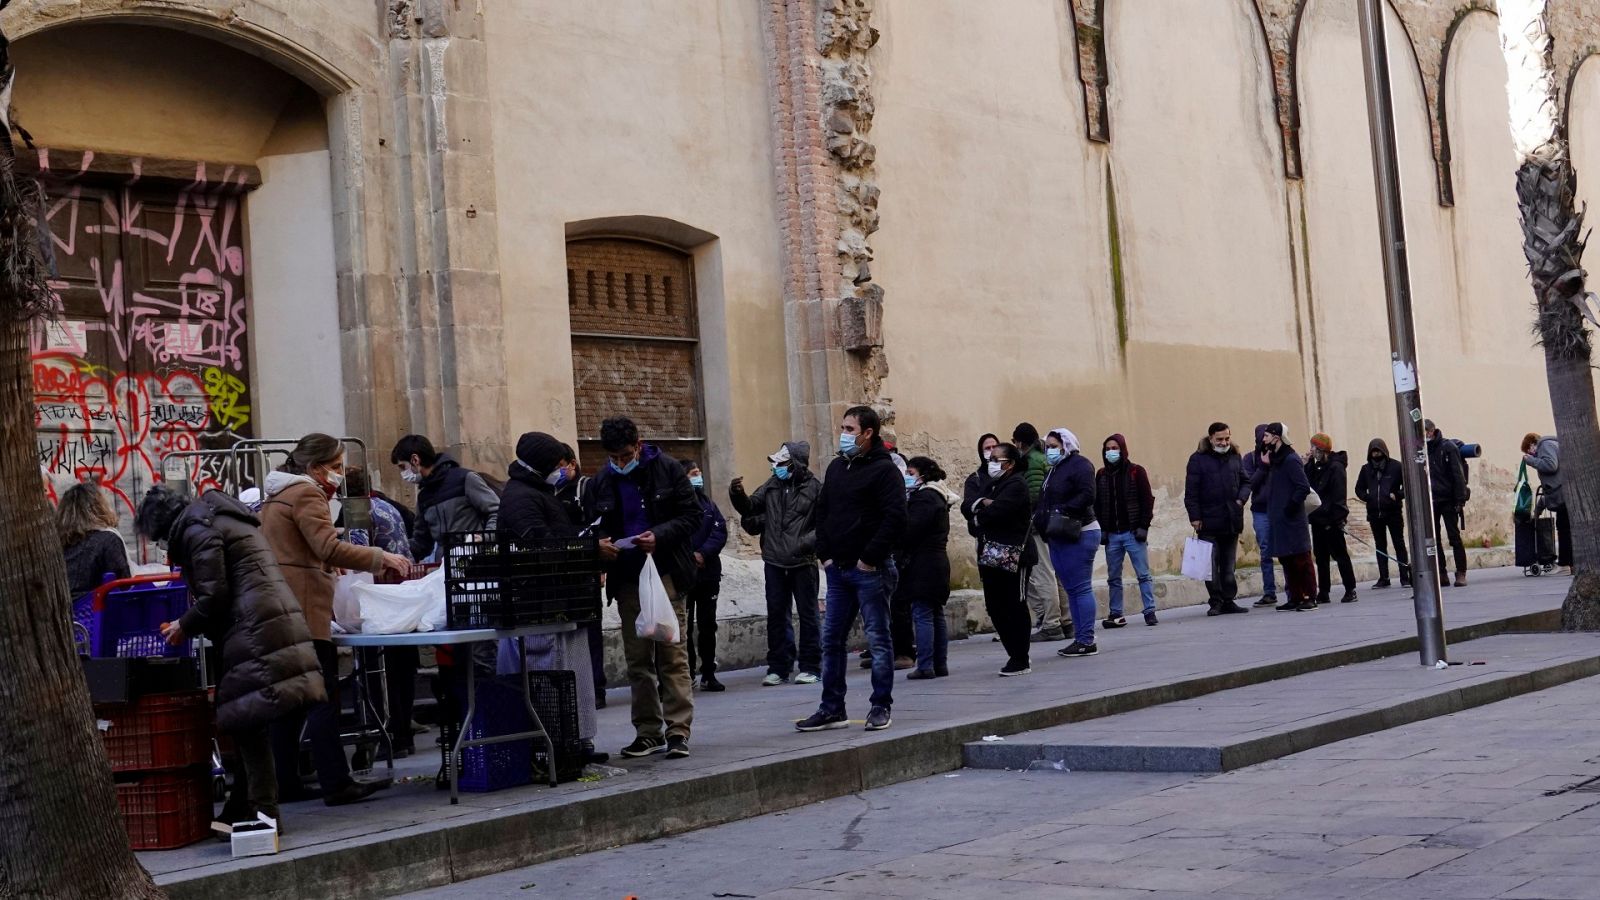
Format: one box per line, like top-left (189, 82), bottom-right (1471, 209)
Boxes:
top-left (152, 570), bottom-right (1568, 898)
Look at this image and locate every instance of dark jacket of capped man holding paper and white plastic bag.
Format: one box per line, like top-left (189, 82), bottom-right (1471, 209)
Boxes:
top-left (584, 444), bottom-right (704, 594)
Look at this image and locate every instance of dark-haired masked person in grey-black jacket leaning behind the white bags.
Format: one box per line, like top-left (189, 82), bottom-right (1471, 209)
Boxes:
top-left (389, 434), bottom-right (499, 560)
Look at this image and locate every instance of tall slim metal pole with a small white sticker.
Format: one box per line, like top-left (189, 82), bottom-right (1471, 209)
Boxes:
top-left (1357, 0), bottom-right (1445, 666)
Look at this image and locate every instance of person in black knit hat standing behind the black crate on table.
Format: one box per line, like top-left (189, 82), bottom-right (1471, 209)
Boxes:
top-left (494, 431), bottom-right (610, 762)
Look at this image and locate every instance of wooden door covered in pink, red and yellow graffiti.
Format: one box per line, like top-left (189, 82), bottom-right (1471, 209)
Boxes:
top-left (32, 154), bottom-right (251, 522)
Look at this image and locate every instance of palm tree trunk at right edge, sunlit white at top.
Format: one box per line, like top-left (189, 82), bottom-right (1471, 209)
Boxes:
top-left (1499, 0), bottom-right (1600, 631)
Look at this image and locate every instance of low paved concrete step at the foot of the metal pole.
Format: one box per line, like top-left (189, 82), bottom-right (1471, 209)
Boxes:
top-left (962, 634), bottom-right (1600, 772)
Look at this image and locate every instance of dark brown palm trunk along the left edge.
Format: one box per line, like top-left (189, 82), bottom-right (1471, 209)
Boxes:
top-left (0, 0), bottom-right (165, 900)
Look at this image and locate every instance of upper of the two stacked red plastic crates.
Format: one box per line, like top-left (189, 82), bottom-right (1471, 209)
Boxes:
top-left (94, 690), bottom-right (211, 772)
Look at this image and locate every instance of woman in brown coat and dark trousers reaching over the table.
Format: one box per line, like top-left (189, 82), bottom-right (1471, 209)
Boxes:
top-left (261, 434), bottom-right (411, 806)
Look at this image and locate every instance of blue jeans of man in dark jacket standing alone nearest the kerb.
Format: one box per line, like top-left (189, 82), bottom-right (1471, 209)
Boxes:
top-left (819, 565), bottom-right (894, 716)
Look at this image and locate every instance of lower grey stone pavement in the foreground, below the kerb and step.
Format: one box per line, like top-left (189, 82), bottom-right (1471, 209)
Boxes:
top-left (411, 679), bottom-right (1600, 900)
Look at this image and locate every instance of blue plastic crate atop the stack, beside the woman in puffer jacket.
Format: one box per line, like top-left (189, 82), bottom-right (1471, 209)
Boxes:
top-left (72, 575), bottom-right (194, 658)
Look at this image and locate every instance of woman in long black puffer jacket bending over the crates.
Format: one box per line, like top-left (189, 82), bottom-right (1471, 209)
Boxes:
top-left (134, 485), bottom-right (326, 831)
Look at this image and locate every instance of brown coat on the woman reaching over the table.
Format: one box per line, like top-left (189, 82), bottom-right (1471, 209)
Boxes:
top-left (261, 472), bottom-right (384, 641)
